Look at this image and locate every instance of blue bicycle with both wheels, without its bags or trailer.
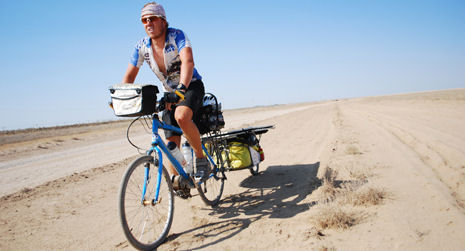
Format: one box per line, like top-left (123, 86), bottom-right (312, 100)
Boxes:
top-left (119, 93), bottom-right (226, 250)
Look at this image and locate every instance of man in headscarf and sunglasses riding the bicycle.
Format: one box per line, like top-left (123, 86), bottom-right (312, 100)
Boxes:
top-left (123, 2), bottom-right (210, 198)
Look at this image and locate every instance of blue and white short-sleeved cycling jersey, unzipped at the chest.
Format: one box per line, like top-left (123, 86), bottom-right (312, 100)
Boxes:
top-left (130, 28), bottom-right (202, 92)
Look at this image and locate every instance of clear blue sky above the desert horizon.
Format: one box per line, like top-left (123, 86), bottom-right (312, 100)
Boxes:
top-left (0, 0), bottom-right (465, 130)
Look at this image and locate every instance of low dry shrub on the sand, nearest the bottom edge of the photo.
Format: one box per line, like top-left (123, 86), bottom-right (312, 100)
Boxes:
top-left (314, 204), bottom-right (361, 229)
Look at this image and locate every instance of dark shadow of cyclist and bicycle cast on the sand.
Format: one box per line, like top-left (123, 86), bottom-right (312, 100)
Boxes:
top-left (167, 162), bottom-right (321, 250)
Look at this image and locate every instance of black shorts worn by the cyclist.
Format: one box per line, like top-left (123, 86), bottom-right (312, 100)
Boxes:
top-left (162, 80), bottom-right (205, 138)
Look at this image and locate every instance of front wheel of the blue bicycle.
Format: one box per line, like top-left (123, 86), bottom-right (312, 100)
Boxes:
top-left (119, 156), bottom-right (174, 250)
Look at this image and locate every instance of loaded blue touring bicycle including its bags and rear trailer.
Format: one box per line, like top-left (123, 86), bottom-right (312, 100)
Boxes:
top-left (109, 84), bottom-right (274, 250)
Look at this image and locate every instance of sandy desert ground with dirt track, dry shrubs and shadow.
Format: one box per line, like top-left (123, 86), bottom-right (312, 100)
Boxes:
top-left (0, 89), bottom-right (465, 250)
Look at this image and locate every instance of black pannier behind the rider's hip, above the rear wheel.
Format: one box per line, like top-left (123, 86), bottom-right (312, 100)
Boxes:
top-left (194, 93), bottom-right (224, 134)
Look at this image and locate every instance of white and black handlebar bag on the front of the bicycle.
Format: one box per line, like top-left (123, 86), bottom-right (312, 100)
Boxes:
top-left (109, 84), bottom-right (158, 117)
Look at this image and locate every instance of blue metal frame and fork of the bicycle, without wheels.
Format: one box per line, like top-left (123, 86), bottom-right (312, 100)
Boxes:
top-left (141, 114), bottom-right (217, 204)
